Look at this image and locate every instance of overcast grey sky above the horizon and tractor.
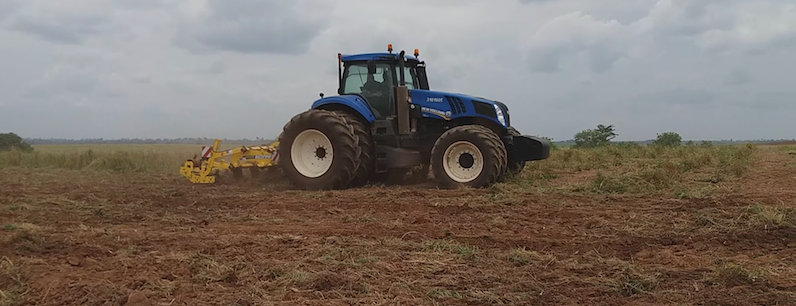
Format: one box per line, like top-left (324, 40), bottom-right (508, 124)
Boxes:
top-left (0, 0), bottom-right (796, 140)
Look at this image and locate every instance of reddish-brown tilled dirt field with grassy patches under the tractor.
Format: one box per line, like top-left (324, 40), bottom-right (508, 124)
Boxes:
top-left (0, 146), bottom-right (796, 305)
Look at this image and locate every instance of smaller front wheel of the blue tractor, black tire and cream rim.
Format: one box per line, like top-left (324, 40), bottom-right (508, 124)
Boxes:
top-left (431, 125), bottom-right (507, 188)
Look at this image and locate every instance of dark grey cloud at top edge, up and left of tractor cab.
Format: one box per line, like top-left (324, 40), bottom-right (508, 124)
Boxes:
top-left (176, 0), bottom-right (326, 53)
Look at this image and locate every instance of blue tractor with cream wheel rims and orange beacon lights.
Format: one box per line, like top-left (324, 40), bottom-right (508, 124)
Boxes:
top-left (277, 45), bottom-right (550, 190)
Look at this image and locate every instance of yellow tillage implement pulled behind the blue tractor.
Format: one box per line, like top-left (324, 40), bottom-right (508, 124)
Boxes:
top-left (180, 139), bottom-right (279, 184)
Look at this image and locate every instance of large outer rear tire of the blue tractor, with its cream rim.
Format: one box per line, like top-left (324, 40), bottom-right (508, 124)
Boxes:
top-left (277, 110), bottom-right (360, 190)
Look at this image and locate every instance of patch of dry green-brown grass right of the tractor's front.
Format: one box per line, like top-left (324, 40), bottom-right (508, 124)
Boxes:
top-left (511, 144), bottom-right (757, 198)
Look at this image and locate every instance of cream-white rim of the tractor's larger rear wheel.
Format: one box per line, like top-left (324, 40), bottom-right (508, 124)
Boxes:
top-left (290, 129), bottom-right (334, 178)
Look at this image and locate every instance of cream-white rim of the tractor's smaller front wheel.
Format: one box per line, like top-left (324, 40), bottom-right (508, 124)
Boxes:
top-left (442, 141), bottom-right (484, 183)
